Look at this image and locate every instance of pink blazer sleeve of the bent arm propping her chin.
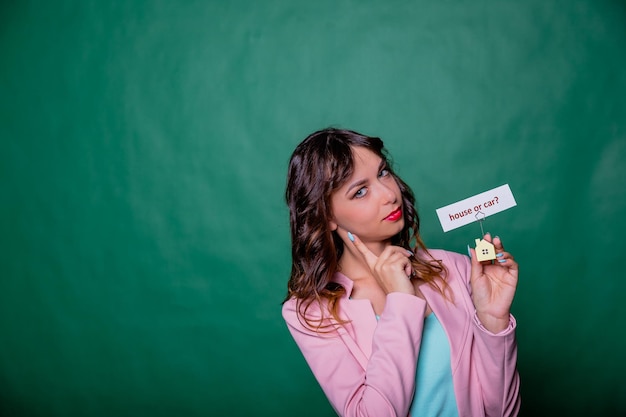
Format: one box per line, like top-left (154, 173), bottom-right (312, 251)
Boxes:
top-left (283, 293), bottom-right (426, 417)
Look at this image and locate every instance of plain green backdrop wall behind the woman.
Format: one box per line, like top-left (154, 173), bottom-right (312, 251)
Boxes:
top-left (0, 0), bottom-right (626, 417)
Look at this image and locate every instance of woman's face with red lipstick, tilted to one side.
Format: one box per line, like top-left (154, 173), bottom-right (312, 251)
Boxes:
top-left (329, 147), bottom-right (404, 243)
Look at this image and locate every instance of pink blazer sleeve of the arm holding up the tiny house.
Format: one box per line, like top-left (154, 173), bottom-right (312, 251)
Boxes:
top-left (448, 249), bottom-right (520, 416)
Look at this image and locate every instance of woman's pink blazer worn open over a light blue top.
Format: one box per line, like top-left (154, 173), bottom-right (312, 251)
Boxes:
top-left (283, 250), bottom-right (520, 417)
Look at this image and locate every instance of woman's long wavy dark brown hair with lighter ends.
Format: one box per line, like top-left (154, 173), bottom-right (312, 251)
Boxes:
top-left (285, 128), bottom-right (447, 331)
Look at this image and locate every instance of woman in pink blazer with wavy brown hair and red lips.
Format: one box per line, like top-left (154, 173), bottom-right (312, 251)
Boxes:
top-left (283, 128), bottom-right (520, 417)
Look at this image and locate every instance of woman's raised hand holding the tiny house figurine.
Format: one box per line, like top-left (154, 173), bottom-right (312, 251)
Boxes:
top-left (470, 233), bottom-right (518, 333)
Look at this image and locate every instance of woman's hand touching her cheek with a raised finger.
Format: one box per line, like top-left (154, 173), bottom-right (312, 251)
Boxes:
top-left (348, 233), bottom-right (415, 295)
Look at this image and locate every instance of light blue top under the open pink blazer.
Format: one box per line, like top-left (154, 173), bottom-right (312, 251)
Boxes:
top-left (410, 313), bottom-right (459, 417)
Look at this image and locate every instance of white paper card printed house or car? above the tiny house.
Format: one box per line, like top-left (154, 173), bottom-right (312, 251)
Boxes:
top-left (436, 184), bottom-right (517, 232)
